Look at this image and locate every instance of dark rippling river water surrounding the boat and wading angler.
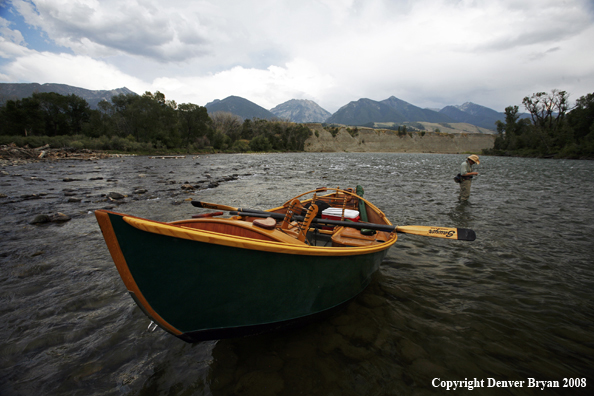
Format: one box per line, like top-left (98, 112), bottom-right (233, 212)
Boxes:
top-left (0, 153), bottom-right (594, 396)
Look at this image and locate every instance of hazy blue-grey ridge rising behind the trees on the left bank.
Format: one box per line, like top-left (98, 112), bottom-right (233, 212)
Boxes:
top-left (0, 83), bottom-right (136, 109)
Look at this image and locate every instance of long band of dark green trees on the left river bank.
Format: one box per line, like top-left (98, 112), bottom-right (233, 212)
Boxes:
top-left (0, 91), bottom-right (312, 153)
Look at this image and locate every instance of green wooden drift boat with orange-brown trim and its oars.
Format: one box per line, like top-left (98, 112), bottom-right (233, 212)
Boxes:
top-left (95, 186), bottom-right (474, 342)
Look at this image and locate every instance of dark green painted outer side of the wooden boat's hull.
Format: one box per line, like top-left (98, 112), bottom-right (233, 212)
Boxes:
top-left (102, 212), bottom-right (387, 342)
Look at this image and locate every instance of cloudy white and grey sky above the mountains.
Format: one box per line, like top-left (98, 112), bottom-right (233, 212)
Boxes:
top-left (0, 0), bottom-right (594, 112)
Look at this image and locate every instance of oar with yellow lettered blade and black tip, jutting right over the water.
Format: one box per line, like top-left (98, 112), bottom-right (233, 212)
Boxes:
top-left (230, 211), bottom-right (476, 241)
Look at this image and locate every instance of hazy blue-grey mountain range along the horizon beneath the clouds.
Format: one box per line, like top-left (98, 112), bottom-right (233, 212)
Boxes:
top-left (0, 83), bottom-right (505, 130)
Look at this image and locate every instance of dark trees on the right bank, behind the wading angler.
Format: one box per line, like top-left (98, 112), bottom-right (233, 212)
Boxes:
top-left (485, 89), bottom-right (594, 158)
